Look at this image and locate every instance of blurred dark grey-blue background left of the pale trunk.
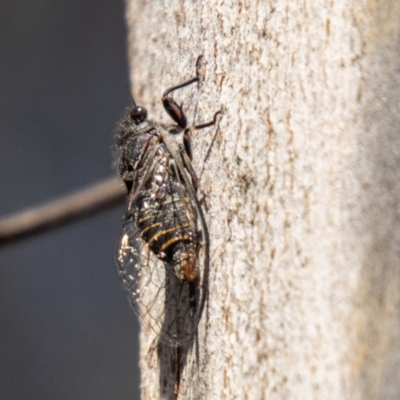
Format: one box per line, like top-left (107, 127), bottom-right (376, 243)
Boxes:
top-left (0, 0), bottom-right (139, 400)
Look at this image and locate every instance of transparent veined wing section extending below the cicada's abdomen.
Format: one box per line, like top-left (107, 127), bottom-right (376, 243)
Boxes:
top-left (115, 222), bottom-right (201, 346)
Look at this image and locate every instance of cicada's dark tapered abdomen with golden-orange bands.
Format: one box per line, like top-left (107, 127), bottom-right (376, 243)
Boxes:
top-left (135, 144), bottom-right (199, 282)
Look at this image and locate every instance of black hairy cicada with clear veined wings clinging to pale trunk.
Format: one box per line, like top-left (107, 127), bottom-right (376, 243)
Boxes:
top-left (115, 65), bottom-right (219, 346)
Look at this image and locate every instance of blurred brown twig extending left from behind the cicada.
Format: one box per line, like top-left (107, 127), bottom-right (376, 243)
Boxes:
top-left (0, 178), bottom-right (126, 246)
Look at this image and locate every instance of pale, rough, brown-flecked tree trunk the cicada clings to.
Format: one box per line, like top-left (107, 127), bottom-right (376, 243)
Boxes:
top-left (127, 0), bottom-right (400, 400)
